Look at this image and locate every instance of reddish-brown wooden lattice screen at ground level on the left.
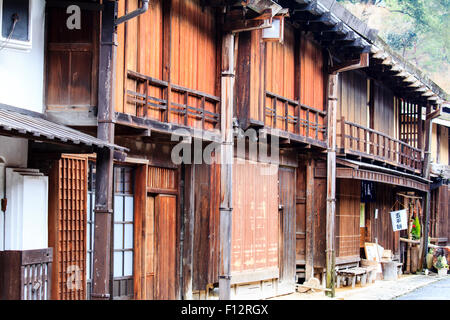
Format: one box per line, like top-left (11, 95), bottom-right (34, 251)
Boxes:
top-left (49, 155), bottom-right (88, 300)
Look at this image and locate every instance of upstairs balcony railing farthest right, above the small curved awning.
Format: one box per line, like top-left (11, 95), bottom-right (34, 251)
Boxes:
top-left (338, 117), bottom-right (422, 172)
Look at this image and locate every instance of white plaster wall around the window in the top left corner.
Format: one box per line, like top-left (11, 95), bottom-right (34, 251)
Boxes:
top-left (0, 0), bottom-right (45, 112)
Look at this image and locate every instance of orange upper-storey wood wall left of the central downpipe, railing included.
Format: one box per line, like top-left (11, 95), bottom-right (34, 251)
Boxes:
top-left (115, 0), bottom-right (220, 129)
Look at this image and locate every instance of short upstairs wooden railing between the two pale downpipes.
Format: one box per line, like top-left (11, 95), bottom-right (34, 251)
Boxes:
top-left (264, 91), bottom-right (326, 141)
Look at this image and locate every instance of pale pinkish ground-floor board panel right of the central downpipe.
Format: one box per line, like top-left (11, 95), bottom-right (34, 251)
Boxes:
top-left (231, 159), bottom-right (279, 274)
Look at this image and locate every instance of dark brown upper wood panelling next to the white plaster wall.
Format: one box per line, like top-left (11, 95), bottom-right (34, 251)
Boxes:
top-left (46, 8), bottom-right (99, 110)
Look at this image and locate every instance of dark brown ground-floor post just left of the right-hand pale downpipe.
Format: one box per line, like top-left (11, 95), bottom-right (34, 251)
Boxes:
top-left (305, 156), bottom-right (316, 281)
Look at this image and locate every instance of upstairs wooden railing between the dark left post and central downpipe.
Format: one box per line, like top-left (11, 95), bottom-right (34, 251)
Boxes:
top-left (126, 70), bottom-right (220, 130)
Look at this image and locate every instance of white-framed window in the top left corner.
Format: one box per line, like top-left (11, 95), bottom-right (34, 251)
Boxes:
top-left (0, 0), bottom-right (31, 50)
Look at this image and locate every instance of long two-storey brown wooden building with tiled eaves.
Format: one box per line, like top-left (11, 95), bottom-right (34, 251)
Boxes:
top-left (1, 0), bottom-right (446, 299)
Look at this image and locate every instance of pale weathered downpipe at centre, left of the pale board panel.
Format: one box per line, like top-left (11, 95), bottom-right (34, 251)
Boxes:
top-left (219, 33), bottom-right (235, 300)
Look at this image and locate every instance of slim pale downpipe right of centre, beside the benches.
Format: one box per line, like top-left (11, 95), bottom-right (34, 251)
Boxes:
top-left (326, 73), bottom-right (338, 297)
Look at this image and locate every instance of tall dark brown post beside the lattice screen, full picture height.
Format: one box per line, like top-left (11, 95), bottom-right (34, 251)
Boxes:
top-left (91, 1), bottom-right (117, 300)
